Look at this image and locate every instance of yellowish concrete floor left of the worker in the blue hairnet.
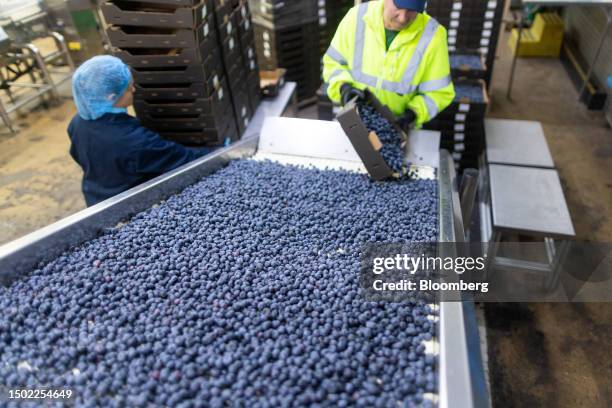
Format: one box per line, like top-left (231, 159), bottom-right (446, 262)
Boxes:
top-left (0, 95), bottom-right (85, 244)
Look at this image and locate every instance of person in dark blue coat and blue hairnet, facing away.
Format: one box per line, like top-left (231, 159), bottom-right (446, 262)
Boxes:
top-left (68, 55), bottom-right (209, 206)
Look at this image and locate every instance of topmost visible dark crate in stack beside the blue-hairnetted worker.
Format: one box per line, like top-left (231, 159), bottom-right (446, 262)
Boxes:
top-left (100, 1), bottom-right (212, 28)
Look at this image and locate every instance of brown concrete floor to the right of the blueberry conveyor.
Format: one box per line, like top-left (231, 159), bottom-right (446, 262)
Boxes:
top-left (485, 29), bottom-right (612, 408)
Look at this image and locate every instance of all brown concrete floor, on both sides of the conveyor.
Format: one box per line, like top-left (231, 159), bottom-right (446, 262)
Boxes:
top-left (0, 21), bottom-right (612, 407)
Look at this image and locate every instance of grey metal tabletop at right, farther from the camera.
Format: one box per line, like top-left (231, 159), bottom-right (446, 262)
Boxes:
top-left (485, 119), bottom-right (555, 168)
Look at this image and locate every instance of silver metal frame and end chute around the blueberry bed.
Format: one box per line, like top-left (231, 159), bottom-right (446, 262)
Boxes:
top-left (0, 116), bottom-right (489, 407)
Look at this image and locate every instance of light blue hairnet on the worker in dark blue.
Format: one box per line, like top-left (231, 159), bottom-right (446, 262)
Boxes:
top-left (72, 55), bottom-right (132, 120)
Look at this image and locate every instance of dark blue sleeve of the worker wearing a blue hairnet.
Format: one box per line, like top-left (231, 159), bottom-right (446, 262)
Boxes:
top-left (128, 126), bottom-right (209, 176)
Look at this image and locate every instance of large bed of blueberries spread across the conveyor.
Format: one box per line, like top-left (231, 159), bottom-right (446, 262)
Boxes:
top-left (0, 160), bottom-right (438, 407)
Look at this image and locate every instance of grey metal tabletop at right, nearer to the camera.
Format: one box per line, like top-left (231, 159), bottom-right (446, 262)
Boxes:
top-left (489, 164), bottom-right (575, 238)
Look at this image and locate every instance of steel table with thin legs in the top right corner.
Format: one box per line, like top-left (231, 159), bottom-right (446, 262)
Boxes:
top-left (507, 0), bottom-right (612, 99)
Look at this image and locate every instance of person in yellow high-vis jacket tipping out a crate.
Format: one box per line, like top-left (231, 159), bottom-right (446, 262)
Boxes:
top-left (323, 0), bottom-right (455, 128)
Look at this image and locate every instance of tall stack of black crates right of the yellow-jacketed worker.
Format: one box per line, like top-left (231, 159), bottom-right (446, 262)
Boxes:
top-left (424, 0), bottom-right (504, 170)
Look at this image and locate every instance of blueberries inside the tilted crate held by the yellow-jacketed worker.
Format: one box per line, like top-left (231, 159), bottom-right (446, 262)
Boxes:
top-left (357, 103), bottom-right (406, 174)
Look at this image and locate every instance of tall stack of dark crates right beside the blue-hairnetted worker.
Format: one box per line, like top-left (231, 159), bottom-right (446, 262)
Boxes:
top-left (101, 0), bottom-right (258, 146)
